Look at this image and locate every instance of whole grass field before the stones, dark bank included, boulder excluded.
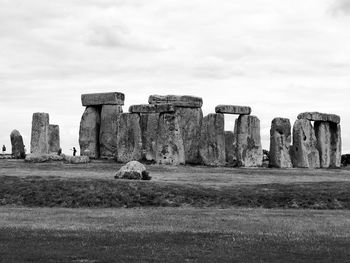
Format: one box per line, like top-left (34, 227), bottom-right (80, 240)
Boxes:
top-left (0, 160), bottom-right (350, 262)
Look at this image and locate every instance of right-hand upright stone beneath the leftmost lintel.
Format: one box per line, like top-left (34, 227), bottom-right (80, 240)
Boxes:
top-left (100, 105), bottom-right (123, 159)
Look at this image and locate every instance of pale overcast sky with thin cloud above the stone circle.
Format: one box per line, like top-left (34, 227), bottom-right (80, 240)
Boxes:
top-left (0, 0), bottom-right (350, 153)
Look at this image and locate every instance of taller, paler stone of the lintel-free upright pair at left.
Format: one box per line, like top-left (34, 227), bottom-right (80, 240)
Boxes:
top-left (30, 112), bottom-right (49, 154)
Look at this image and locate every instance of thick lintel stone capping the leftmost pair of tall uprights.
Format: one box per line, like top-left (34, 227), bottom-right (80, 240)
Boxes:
top-left (81, 92), bottom-right (125, 106)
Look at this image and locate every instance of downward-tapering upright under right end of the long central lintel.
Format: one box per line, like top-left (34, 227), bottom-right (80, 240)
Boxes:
top-left (175, 108), bottom-right (203, 164)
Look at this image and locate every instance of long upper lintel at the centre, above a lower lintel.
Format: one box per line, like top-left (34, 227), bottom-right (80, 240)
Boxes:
top-left (148, 95), bottom-right (203, 108)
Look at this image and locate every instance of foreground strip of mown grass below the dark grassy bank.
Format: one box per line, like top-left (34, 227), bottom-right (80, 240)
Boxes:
top-left (0, 208), bottom-right (350, 262)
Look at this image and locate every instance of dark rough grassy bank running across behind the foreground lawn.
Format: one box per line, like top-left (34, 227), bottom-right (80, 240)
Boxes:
top-left (0, 176), bottom-right (350, 209)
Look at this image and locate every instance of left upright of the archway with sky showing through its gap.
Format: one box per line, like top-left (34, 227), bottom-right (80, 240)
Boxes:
top-left (199, 113), bottom-right (226, 166)
